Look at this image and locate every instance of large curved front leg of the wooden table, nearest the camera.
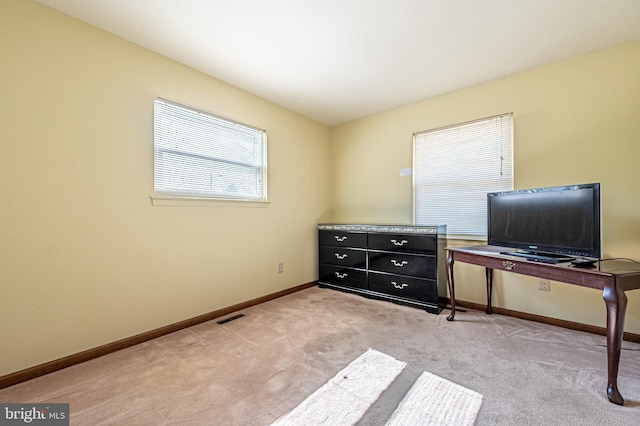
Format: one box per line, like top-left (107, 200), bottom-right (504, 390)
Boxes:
top-left (603, 283), bottom-right (627, 405)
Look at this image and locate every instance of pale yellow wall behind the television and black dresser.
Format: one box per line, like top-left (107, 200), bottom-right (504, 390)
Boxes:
top-left (331, 41), bottom-right (640, 333)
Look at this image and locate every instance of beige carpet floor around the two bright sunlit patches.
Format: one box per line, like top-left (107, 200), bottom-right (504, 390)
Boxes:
top-left (0, 287), bottom-right (640, 426)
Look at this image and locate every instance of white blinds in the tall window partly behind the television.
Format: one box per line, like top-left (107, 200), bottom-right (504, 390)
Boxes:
top-left (414, 114), bottom-right (513, 238)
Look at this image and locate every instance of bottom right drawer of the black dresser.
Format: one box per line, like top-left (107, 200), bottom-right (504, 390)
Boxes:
top-left (369, 272), bottom-right (438, 302)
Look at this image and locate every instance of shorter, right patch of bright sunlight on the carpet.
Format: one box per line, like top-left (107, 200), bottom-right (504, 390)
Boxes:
top-left (387, 372), bottom-right (482, 426)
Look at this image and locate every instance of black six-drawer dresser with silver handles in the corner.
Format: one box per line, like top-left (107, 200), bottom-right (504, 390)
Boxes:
top-left (318, 224), bottom-right (448, 314)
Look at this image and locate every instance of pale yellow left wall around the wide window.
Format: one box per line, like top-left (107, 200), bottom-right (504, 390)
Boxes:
top-left (0, 0), bottom-right (330, 375)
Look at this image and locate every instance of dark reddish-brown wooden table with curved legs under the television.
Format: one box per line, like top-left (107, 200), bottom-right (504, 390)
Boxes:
top-left (446, 246), bottom-right (640, 405)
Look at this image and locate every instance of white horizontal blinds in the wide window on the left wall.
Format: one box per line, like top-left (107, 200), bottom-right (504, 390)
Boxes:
top-left (154, 99), bottom-right (266, 200)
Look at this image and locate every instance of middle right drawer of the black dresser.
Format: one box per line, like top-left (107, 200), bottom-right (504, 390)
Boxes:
top-left (368, 251), bottom-right (437, 279)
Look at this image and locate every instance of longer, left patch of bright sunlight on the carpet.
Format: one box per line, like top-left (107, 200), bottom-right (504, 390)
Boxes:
top-left (273, 349), bottom-right (407, 426)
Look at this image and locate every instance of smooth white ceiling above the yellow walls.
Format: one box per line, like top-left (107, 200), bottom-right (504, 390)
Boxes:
top-left (38, 0), bottom-right (640, 126)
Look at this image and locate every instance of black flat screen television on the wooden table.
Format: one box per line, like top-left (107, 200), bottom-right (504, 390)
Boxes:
top-left (487, 183), bottom-right (601, 263)
